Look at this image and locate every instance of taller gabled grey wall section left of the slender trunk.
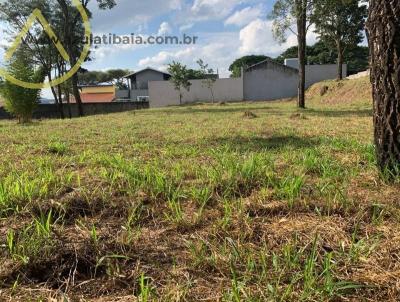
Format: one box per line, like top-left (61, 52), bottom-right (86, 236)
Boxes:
top-left (243, 61), bottom-right (298, 101)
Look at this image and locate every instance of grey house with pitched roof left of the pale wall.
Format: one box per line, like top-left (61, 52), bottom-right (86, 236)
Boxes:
top-left (116, 67), bottom-right (171, 102)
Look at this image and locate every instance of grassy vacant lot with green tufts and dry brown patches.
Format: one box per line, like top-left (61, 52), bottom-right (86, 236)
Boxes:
top-left (0, 79), bottom-right (400, 302)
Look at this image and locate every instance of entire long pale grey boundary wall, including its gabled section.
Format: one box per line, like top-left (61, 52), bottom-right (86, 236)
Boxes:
top-left (149, 61), bottom-right (347, 108)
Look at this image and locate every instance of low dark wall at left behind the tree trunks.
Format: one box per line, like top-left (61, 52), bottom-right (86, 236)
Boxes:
top-left (0, 102), bottom-right (149, 119)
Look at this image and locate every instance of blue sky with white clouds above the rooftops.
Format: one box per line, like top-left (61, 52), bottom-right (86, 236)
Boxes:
top-left (0, 0), bottom-right (317, 96)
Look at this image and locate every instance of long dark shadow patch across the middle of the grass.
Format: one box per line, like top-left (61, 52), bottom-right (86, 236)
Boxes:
top-left (207, 135), bottom-right (321, 152)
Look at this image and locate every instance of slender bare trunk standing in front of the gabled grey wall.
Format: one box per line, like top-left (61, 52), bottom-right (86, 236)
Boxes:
top-left (296, 0), bottom-right (307, 108)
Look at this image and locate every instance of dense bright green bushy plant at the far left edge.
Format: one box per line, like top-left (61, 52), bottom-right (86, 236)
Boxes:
top-left (0, 49), bottom-right (43, 123)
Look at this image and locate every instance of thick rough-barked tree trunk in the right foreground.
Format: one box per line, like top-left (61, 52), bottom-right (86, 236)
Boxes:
top-left (367, 0), bottom-right (400, 175)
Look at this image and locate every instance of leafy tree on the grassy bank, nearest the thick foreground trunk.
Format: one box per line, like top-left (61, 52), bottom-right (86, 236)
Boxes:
top-left (312, 0), bottom-right (367, 80)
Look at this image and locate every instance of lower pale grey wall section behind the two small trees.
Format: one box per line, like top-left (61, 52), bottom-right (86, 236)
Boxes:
top-left (149, 78), bottom-right (244, 108)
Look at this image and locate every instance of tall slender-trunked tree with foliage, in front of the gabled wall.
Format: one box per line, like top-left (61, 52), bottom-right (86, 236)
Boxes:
top-left (270, 0), bottom-right (314, 108)
